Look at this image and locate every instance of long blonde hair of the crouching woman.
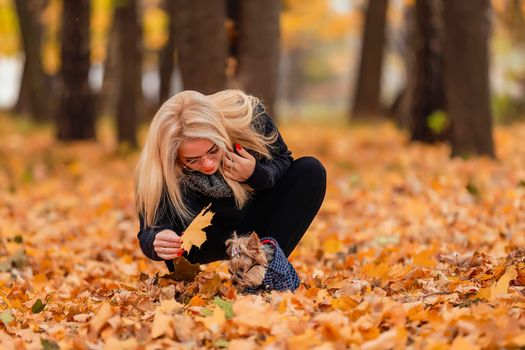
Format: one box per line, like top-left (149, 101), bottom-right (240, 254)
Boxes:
top-left (135, 90), bottom-right (277, 227)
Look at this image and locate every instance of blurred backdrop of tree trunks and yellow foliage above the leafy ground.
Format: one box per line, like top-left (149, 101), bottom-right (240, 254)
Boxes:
top-left (0, 0), bottom-right (525, 155)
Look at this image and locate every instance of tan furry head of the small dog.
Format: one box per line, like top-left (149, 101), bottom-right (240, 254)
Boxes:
top-left (226, 232), bottom-right (268, 287)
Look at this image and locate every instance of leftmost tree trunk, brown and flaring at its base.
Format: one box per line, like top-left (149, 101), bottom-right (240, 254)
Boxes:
top-left (15, 0), bottom-right (52, 122)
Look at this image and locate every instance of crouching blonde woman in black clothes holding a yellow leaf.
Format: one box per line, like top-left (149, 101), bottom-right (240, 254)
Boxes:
top-left (135, 90), bottom-right (326, 271)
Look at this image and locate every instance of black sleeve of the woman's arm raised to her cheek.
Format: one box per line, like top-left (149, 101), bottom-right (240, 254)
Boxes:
top-left (245, 103), bottom-right (293, 191)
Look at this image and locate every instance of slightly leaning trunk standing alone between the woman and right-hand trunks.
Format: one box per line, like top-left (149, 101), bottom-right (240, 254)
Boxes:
top-left (352, 0), bottom-right (388, 119)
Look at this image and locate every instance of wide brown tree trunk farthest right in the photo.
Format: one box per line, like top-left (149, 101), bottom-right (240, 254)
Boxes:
top-left (443, 0), bottom-right (494, 157)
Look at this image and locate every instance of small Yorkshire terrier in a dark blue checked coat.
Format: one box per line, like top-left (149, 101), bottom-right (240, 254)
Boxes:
top-left (226, 232), bottom-right (300, 293)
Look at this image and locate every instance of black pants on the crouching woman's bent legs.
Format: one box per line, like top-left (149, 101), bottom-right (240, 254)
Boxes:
top-left (175, 157), bottom-right (326, 270)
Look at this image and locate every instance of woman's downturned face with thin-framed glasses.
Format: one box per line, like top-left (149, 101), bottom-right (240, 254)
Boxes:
top-left (179, 139), bottom-right (223, 175)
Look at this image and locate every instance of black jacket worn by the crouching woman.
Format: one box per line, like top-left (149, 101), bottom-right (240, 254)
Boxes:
top-left (137, 104), bottom-right (293, 268)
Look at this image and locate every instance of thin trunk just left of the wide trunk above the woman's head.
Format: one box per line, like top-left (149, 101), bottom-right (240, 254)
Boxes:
top-left (159, 0), bottom-right (177, 105)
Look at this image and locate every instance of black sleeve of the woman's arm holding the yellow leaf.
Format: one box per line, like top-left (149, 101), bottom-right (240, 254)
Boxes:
top-left (137, 193), bottom-right (206, 261)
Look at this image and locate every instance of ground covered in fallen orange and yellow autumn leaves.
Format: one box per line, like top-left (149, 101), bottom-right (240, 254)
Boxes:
top-left (0, 116), bottom-right (525, 349)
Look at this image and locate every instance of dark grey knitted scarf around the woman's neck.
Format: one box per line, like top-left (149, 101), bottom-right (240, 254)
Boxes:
top-left (184, 171), bottom-right (233, 198)
